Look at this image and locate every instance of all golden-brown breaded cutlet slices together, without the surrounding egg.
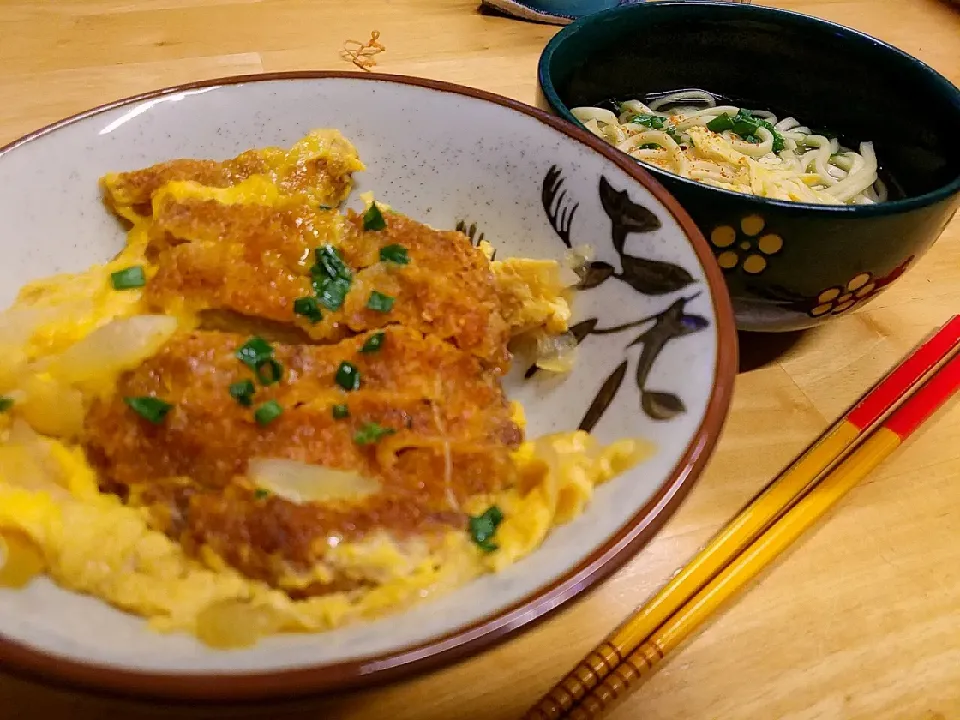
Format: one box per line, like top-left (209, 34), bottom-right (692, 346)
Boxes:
top-left (83, 130), bottom-right (569, 597)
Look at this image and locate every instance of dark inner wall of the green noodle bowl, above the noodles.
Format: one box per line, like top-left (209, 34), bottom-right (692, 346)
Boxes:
top-left (540, 2), bottom-right (960, 197)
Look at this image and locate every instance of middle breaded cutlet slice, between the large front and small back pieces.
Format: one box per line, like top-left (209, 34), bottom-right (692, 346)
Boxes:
top-left (144, 183), bottom-right (510, 370)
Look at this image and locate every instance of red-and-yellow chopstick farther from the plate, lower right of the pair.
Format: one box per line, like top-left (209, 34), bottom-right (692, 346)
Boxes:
top-left (566, 346), bottom-right (960, 720)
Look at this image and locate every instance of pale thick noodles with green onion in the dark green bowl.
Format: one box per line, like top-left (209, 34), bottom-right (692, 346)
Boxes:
top-left (572, 90), bottom-right (887, 205)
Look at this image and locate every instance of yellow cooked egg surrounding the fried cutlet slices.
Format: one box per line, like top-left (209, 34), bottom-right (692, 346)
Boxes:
top-left (0, 134), bottom-right (652, 648)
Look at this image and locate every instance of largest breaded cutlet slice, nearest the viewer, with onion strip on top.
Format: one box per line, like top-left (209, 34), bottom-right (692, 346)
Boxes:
top-left (83, 326), bottom-right (522, 583)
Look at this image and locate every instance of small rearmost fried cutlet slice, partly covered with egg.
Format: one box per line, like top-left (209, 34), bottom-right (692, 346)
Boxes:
top-left (100, 130), bottom-right (364, 220)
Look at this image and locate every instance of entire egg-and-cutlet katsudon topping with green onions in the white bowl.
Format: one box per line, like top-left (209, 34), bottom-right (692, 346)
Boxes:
top-left (0, 130), bottom-right (651, 648)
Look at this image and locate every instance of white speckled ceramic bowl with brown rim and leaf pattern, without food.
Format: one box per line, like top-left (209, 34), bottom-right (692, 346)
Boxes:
top-left (0, 73), bottom-right (736, 700)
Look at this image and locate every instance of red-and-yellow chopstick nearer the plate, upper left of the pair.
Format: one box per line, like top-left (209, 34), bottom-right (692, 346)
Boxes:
top-left (524, 315), bottom-right (960, 720)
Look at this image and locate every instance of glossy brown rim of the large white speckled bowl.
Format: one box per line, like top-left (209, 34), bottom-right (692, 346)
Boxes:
top-left (0, 70), bottom-right (737, 702)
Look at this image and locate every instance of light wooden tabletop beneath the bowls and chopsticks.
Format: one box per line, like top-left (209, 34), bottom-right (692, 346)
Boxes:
top-left (0, 0), bottom-right (960, 720)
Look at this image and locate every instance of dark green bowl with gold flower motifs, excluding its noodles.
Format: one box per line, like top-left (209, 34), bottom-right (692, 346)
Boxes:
top-left (539, 1), bottom-right (960, 331)
